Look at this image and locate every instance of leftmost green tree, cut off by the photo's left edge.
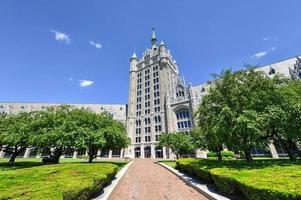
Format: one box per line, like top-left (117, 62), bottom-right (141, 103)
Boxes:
top-left (0, 112), bottom-right (39, 165)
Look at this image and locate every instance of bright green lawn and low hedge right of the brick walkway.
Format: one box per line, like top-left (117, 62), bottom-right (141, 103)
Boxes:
top-left (177, 159), bottom-right (301, 200)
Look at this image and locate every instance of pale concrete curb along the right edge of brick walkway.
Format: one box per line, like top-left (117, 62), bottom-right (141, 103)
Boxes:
top-left (156, 161), bottom-right (230, 200)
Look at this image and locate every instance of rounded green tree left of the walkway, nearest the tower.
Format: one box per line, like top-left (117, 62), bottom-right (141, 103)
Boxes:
top-left (73, 109), bottom-right (130, 163)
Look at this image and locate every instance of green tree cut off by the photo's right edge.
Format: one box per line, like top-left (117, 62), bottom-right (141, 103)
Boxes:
top-left (263, 80), bottom-right (301, 160)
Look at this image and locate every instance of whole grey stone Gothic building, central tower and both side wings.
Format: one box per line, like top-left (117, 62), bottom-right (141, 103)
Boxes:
top-left (0, 30), bottom-right (301, 158)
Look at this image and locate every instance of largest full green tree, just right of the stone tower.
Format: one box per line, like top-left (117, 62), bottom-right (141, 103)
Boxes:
top-left (196, 66), bottom-right (278, 161)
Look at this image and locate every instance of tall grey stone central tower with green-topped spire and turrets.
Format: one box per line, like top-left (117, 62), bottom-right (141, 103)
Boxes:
top-left (127, 29), bottom-right (191, 158)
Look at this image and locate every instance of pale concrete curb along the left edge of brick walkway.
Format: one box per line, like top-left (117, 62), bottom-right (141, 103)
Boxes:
top-left (92, 160), bottom-right (133, 200)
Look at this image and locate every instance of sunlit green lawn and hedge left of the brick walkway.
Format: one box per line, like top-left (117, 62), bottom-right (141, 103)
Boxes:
top-left (0, 159), bottom-right (125, 200)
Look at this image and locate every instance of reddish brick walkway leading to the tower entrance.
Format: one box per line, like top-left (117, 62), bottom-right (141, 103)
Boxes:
top-left (109, 159), bottom-right (207, 200)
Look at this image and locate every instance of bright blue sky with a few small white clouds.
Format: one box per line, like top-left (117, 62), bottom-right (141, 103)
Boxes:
top-left (0, 0), bottom-right (301, 103)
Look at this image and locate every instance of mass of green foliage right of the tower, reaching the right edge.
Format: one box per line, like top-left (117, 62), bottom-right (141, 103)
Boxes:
top-left (196, 66), bottom-right (301, 162)
